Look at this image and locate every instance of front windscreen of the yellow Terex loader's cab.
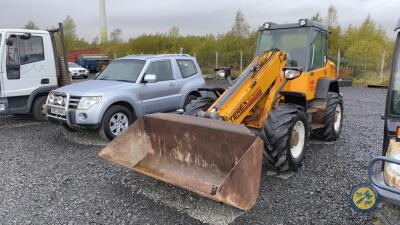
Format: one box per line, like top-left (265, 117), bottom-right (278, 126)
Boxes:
top-left (256, 28), bottom-right (308, 68)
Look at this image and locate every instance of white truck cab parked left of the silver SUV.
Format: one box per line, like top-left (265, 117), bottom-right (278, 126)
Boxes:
top-left (0, 24), bottom-right (71, 121)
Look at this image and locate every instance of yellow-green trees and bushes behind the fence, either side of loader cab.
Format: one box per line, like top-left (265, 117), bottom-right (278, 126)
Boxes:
top-left (27, 9), bottom-right (394, 80)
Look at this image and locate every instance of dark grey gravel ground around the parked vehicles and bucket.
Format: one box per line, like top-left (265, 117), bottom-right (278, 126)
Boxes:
top-left (0, 85), bottom-right (396, 224)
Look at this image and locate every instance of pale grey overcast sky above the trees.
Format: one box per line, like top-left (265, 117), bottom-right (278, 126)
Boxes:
top-left (0, 0), bottom-right (400, 41)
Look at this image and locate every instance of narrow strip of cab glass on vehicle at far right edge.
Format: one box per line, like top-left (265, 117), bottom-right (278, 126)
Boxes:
top-left (391, 34), bottom-right (400, 116)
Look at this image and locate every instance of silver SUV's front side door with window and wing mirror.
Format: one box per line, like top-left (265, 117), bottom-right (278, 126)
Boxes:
top-left (139, 60), bottom-right (179, 113)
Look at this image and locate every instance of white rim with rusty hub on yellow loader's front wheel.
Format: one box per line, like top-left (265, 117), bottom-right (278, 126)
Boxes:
top-left (290, 121), bottom-right (306, 158)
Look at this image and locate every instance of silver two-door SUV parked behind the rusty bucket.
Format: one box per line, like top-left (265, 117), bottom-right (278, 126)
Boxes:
top-left (45, 55), bottom-right (205, 140)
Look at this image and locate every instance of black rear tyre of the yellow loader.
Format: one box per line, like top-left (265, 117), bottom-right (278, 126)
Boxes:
top-left (316, 92), bottom-right (343, 141)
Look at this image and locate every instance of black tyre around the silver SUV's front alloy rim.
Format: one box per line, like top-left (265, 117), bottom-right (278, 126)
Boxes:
top-left (99, 105), bottom-right (136, 140)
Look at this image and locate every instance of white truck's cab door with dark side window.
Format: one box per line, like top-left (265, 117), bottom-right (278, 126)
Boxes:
top-left (3, 33), bottom-right (50, 97)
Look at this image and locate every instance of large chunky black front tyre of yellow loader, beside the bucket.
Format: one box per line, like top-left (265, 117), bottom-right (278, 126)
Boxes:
top-left (261, 104), bottom-right (309, 172)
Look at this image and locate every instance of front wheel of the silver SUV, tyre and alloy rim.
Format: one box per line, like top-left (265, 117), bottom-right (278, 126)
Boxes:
top-left (99, 105), bottom-right (134, 140)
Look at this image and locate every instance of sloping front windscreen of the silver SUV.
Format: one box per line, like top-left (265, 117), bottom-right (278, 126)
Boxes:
top-left (97, 59), bottom-right (146, 83)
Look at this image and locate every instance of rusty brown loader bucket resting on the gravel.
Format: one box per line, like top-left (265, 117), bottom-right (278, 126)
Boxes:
top-left (100, 113), bottom-right (263, 210)
